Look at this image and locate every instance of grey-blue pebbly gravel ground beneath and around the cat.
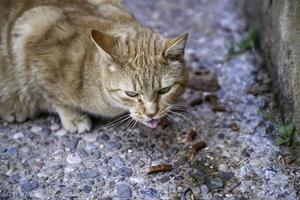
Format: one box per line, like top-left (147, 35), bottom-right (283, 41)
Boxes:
top-left (0, 0), bottom-right (300, 200)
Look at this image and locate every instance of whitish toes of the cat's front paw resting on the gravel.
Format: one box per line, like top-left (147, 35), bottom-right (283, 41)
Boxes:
top-left (61, 115), bottom-right (92, 133)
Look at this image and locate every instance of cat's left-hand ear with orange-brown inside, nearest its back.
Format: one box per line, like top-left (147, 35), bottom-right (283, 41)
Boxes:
top-left (91, 30), bottom-right (118, 58)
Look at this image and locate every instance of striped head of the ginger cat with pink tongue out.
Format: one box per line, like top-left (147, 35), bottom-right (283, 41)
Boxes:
top-left (92, 29), bottom-right (188, 128)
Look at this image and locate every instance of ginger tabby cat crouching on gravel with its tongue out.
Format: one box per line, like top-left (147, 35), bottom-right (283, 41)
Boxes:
top-left (0, 0), bottom-right (187, 132)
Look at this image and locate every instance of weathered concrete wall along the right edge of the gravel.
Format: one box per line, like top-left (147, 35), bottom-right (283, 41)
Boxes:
top-left (238, 0), bottom-right (300, 146)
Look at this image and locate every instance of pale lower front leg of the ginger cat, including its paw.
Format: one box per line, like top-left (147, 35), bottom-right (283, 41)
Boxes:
top-left (54, 106), bottom-right (92, 133)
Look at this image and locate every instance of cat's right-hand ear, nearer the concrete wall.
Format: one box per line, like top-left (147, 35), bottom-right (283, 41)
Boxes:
top-left (164, 33), bottom-right (188, 61)
